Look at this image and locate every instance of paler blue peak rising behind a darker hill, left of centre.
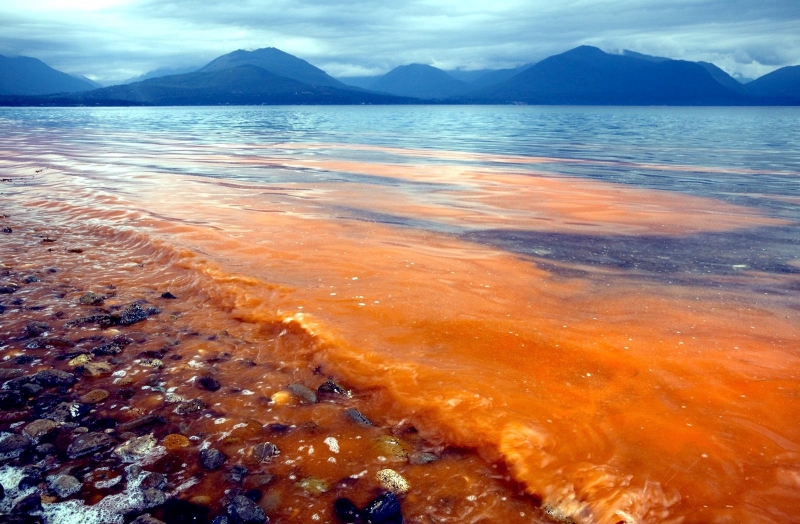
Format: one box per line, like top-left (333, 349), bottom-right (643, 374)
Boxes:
top-left (199, 47), bottom-right (347, 89)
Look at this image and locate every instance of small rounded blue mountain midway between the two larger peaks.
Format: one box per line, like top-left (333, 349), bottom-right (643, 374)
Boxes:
top-left (371, 64), bottom-right (469, 99)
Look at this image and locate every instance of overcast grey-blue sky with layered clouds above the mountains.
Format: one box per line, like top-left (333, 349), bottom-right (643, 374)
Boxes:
top-left (0, 0), bottom-right (800, 82)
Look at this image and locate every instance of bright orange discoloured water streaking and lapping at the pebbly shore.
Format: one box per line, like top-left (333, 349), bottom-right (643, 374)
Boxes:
top-left (0, 124), bottom-right (800, 522)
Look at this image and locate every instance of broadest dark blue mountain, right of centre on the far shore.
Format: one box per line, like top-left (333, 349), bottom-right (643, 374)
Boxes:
top-left (470, 46), bottom-right (752, 105)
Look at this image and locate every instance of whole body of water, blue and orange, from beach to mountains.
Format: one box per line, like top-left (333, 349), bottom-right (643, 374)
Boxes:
top-left (0, 106), bottom-right (800, 522)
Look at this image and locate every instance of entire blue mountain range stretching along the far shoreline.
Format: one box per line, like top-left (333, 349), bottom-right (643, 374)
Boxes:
top-left (0, 46), bottom-right (800, 105)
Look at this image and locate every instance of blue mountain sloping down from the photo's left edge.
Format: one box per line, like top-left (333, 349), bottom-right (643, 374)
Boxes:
top-left (0, 55), bottom-right (94, 95)
